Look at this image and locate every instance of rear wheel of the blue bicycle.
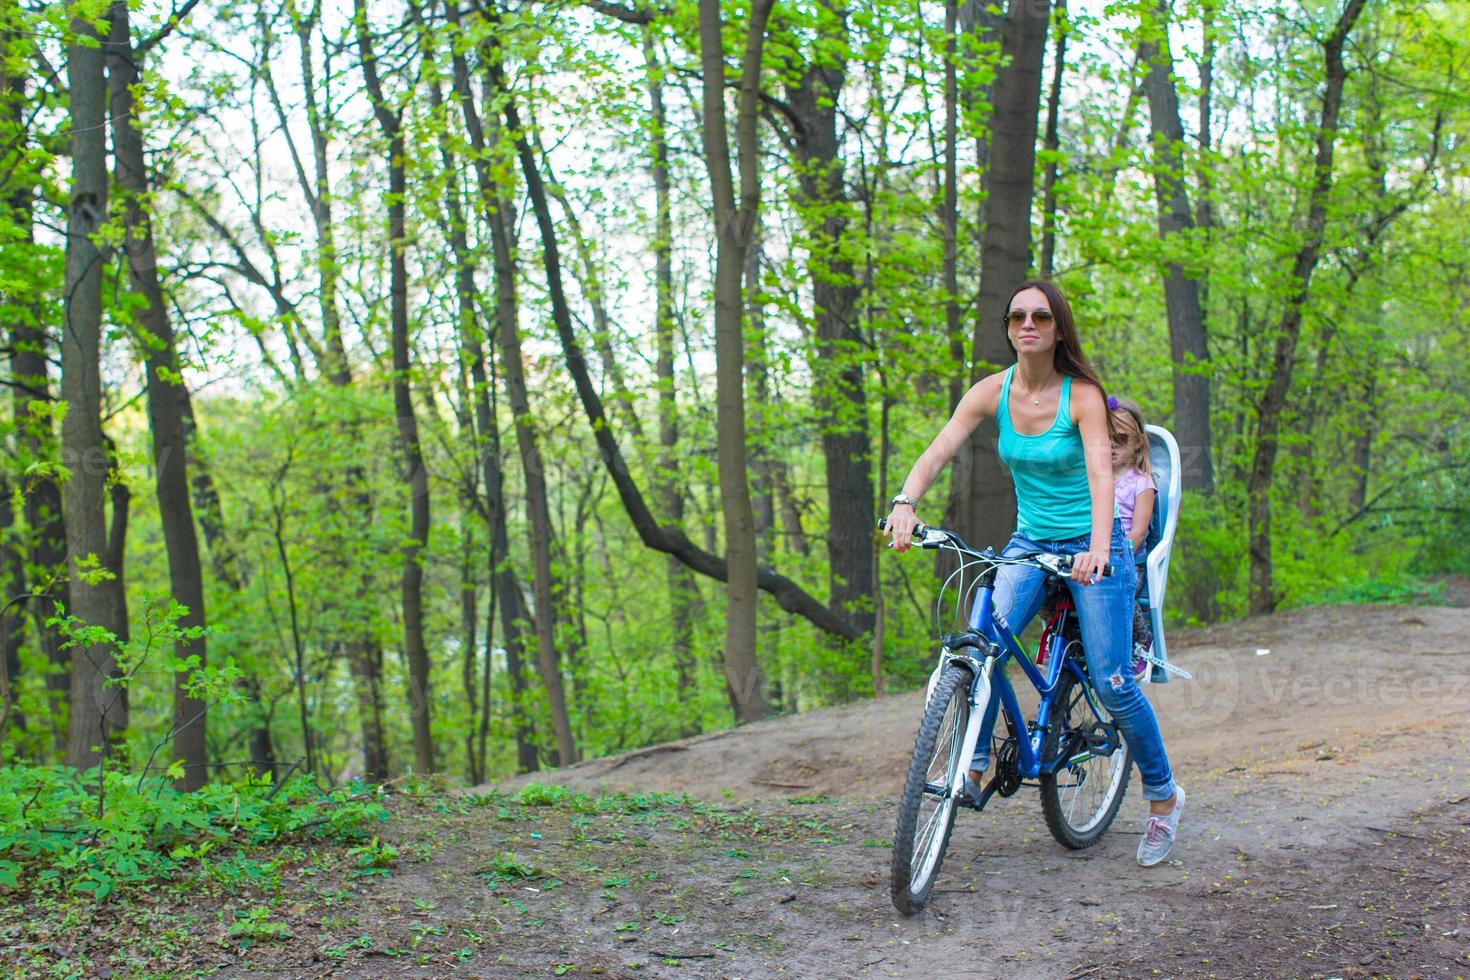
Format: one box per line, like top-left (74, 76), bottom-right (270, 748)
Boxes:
top-left (1041, 671), bottom-right (1133, 851)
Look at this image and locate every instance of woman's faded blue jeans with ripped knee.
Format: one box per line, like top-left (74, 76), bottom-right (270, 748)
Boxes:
top-left (970, 520), bottom-right (1175, 799)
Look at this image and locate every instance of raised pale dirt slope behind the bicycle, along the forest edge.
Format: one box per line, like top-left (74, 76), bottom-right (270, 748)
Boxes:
top-left (485, 605), bottom-right (1470, 799)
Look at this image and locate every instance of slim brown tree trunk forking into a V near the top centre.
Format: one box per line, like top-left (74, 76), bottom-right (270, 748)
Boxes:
top-left (700, 0), bottom-right (775, 721)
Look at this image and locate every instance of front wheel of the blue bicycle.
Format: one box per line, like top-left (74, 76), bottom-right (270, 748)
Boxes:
top-left (892, 664), bottom-right (972, 915)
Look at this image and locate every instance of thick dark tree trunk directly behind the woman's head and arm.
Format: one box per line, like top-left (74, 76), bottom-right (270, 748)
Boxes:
top-left (947, 0), bottom-right (1051, 547)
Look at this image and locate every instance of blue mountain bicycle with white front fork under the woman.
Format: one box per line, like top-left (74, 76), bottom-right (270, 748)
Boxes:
top-left (881, 525), bottom-right (1132, 915)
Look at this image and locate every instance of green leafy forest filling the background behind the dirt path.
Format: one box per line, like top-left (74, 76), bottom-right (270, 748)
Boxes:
top-left (0, 0), bottom-right (1470, 799)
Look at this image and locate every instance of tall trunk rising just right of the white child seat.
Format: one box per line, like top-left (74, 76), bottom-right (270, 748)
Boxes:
top-left (1139, 0), bottom-right (1214, 492)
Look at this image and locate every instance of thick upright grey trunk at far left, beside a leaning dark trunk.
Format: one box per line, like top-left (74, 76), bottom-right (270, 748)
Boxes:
top-left (62, 9), bottom-right (126, 770)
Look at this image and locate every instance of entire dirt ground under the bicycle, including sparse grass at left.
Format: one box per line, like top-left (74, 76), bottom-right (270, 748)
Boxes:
top-left (28, 607), bottom-right (1470, 979)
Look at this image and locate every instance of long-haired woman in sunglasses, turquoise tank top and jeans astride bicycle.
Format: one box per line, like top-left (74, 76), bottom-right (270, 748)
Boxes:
top-left (886, 281), bottom-right (1185, 865)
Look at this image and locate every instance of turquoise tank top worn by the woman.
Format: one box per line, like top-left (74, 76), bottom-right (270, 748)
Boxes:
top-left (995, 364), bottom-right (1092, 541)
